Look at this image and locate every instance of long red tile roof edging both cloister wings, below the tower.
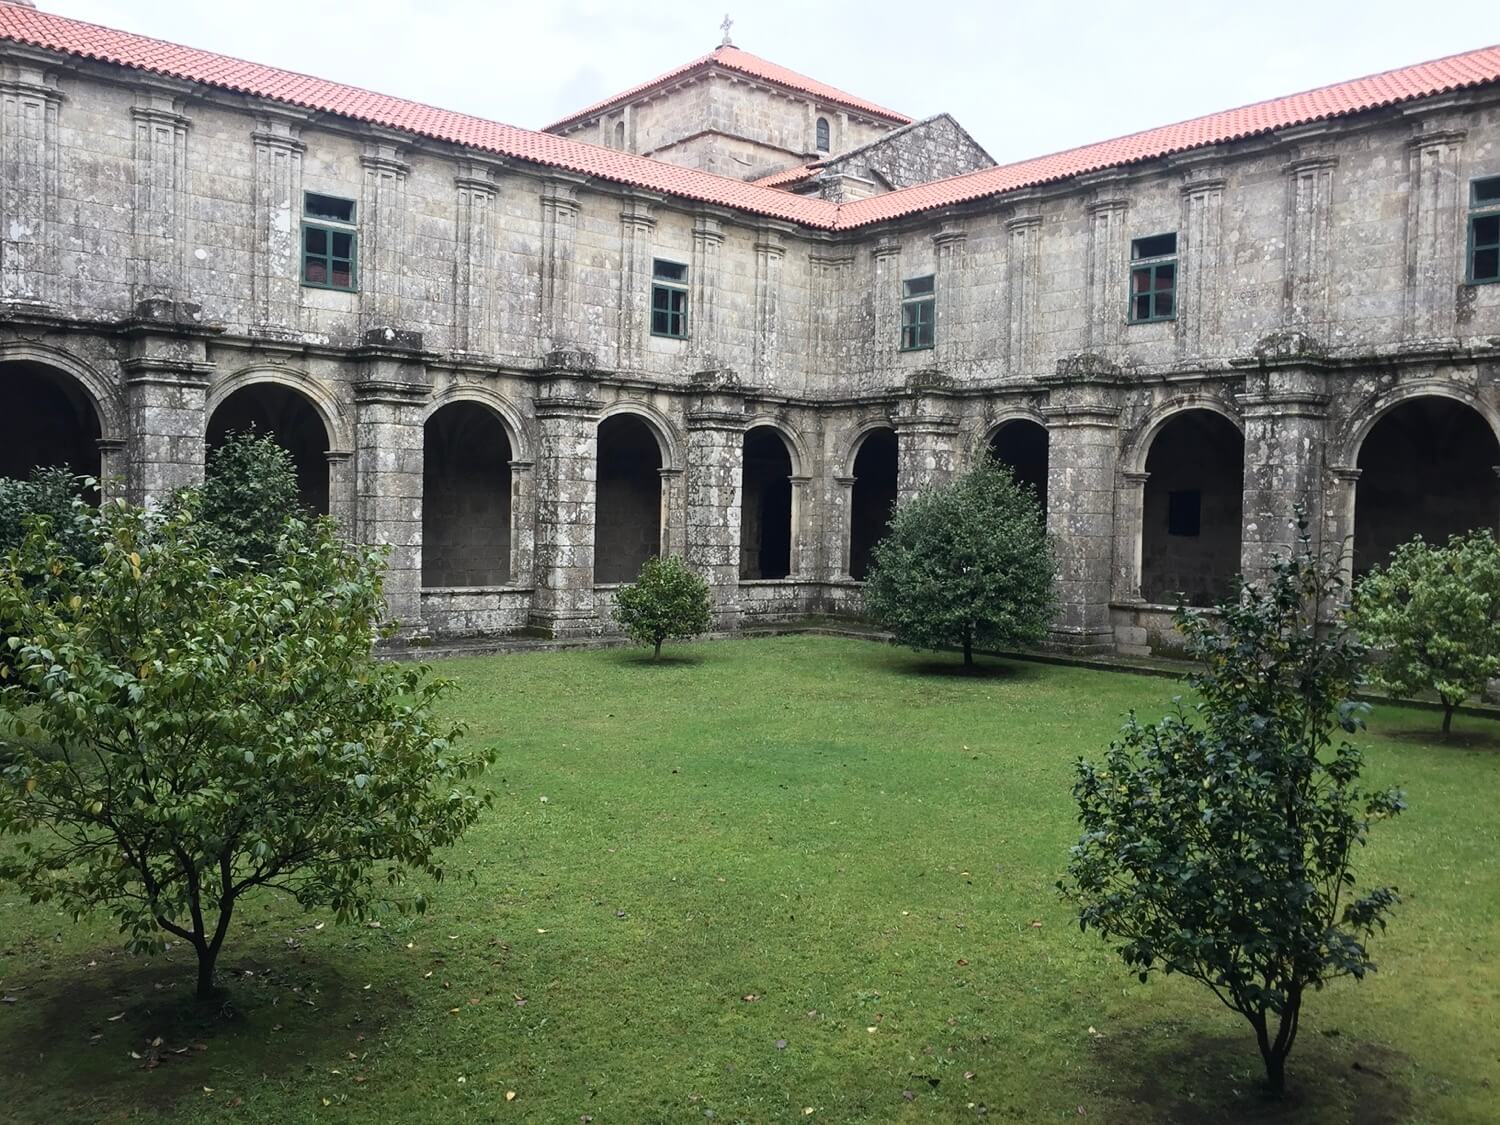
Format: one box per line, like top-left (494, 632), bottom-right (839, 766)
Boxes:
top-left (0, 3), bottom-right (1500, 230)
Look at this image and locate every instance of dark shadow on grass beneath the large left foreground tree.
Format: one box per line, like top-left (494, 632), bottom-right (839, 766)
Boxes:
top-left (0, 950), bottom-right (410, 1122)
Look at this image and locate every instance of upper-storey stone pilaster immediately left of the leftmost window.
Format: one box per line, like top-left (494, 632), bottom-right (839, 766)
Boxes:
top-left (251, 114), bottom-right (308, 333)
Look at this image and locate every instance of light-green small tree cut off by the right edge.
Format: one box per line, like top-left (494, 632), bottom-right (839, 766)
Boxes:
top-left (1355, 531), bottom-right (1500, 738)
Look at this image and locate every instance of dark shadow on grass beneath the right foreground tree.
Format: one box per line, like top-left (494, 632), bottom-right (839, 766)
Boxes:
top-left (1095, 1025), bottom-right (1412, 1125)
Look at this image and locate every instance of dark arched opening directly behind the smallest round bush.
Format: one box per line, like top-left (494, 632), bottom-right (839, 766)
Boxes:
top-left (594, 414), bottom-right (662, 584)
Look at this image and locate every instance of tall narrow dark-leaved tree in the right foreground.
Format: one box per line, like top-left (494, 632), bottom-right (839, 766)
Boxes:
top-left (1059, 525), bottom-right (1406, 1095)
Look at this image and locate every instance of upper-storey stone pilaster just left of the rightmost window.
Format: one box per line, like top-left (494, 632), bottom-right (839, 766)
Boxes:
top-left (1406, 129), bottom-right (1466, 341)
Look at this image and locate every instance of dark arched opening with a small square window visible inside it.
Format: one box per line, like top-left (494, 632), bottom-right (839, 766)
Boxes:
top-left (1140, 410), bottom-right (1245, 606)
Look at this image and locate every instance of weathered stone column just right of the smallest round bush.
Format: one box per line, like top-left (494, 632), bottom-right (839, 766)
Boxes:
top-left (684, 372), bottom-right (746, 629)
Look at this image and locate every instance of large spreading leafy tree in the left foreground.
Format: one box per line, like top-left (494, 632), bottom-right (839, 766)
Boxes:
top-left (0, 495), bottom-right (489, 996)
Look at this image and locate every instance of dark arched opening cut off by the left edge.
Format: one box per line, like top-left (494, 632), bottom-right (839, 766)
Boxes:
top-left (0, 360), bottom-right (101, 480)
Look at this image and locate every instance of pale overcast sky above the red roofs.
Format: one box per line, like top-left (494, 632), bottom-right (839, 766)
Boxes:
top-left (38, 0), bottom-right (1500, 164)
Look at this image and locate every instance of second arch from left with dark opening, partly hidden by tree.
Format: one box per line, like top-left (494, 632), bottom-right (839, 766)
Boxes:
top-left (204, 369), bottom-right (339, 515)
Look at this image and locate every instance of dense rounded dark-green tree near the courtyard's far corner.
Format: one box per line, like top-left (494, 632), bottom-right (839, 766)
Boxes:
top-left (864, 458), bottom-right (1056, 666)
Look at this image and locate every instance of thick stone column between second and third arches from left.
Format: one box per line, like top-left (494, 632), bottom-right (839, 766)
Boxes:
top-left (348, 329), bottom-right (432, 636)
